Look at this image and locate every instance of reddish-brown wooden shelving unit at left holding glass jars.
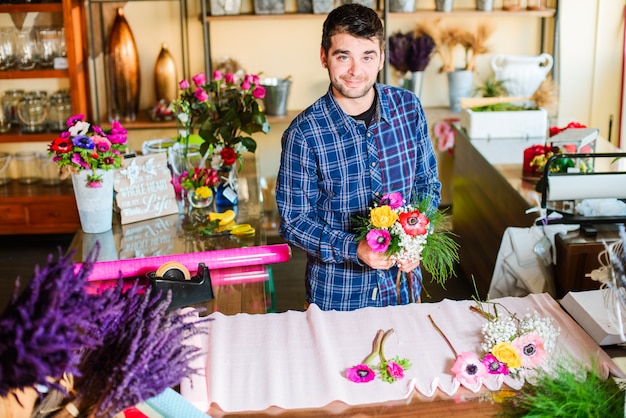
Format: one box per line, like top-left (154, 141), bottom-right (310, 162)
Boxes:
top-left (0, 0), bottom-right (90, 234)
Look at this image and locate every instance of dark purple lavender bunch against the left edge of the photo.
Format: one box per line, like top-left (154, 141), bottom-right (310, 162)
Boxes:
top-left (0, 249), bottom-right (116, 396)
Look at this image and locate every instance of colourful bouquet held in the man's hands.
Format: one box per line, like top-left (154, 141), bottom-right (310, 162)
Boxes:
top-left (355, 192), bottom-right (459, 285)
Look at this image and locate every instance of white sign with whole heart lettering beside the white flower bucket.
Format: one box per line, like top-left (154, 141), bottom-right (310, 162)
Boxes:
top-left (113, 153), bottom-right (178, 225)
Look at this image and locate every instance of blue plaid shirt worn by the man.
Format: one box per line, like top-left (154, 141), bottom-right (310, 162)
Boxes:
top-left (276, 84), bottom-right (441, 310)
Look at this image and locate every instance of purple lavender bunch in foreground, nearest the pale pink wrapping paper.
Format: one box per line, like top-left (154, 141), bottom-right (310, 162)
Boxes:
top-left (74, 284), bottom-right (208, 417)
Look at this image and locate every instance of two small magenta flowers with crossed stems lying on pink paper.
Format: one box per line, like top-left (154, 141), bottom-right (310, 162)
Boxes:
top-left (346, 328), bottom-right (411, 383)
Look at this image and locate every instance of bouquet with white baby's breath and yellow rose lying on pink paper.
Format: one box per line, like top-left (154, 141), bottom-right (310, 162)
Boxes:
top-left (452, 302), bottom-right (560, 383)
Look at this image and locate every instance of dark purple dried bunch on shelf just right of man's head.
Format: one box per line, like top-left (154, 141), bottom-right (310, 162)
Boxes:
top-left (388, 32), bottom-right (435, 73)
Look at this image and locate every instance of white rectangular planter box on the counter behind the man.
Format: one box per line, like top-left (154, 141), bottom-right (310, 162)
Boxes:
top-left (460, 109), bottom-right (548, 139)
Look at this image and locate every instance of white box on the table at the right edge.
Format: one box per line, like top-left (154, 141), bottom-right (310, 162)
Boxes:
top-left (561, 289), bottom-right (626, 345)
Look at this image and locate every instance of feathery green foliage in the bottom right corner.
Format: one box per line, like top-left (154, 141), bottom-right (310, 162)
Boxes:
top-left (499, 361), bottom-right (624, 418)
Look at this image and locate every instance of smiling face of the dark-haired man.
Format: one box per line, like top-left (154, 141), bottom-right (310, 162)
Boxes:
top-left (320, 33), bottom-right (385, 99)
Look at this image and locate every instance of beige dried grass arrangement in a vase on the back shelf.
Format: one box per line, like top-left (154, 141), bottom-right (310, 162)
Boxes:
top-left (416, 20), bottom-right (495, 73)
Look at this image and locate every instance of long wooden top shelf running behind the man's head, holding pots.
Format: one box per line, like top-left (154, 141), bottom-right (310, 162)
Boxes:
top-left (206, 8), bottom-right (556, 22)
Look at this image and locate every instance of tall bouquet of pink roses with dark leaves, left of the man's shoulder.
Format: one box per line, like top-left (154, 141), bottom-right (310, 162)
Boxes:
top-left (173, 70), bottom-right (270, 169)
